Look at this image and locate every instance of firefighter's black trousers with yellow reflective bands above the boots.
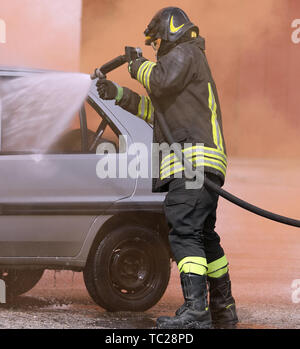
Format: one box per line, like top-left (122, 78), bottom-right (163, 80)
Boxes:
top-left (164, 178), bottom-right (228, 278)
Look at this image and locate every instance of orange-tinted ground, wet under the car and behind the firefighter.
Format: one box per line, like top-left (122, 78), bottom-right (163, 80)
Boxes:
top-left (0, 159), bottom-right (300, 329)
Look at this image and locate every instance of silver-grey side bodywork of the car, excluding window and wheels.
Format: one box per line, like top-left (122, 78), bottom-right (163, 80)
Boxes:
top-left (0, 67), bottom-right (164, 268)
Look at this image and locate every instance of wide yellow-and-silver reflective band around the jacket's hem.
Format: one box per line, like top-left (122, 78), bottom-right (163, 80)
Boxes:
top-left (160, 146), bottom-right (227, 180)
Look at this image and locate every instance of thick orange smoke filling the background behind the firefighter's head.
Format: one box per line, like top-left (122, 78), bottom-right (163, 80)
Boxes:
top-left (81, 0), bottom-right (300, 157)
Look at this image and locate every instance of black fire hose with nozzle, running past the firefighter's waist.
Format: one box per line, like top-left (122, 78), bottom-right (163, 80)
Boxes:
top-left (91, 46), bottom-right (300, 228)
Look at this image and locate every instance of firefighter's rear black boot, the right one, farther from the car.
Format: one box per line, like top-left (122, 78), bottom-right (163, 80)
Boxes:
top-left (207, 273), bottom-right (238, 328)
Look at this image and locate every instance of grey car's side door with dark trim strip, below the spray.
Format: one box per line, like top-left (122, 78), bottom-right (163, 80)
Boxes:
top-left (0, 78), bottom-right (136, 258)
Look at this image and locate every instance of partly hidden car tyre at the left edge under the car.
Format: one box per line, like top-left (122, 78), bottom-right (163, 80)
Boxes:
top-left (0, 269), bottom-right (44, 297)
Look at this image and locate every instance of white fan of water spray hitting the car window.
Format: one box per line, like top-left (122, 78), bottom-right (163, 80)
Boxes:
top-left (0, 72), bottom-right (92, 154)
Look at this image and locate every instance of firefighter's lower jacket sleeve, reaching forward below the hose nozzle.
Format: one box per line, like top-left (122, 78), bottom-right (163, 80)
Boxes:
top-left (116, 87), bottom-right (154, 124)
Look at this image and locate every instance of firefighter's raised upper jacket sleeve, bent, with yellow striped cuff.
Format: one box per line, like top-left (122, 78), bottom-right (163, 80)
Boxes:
top-left (137, 45), bottom-right (195, 97)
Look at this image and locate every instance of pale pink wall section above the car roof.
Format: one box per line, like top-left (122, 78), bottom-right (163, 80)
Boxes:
top-left (0, 0), bottom-right (81, 71)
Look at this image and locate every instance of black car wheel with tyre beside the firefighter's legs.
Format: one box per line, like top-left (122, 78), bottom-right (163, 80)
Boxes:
top-left (84, 226), bottom-right (170, 311)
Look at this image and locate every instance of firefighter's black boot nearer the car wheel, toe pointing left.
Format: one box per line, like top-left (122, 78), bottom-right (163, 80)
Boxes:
top-left (156, 273), bottom-right (212, 329)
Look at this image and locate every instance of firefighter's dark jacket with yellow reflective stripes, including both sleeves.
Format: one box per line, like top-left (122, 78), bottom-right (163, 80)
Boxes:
top-left (117, 37), bottom-right (227, 192)
